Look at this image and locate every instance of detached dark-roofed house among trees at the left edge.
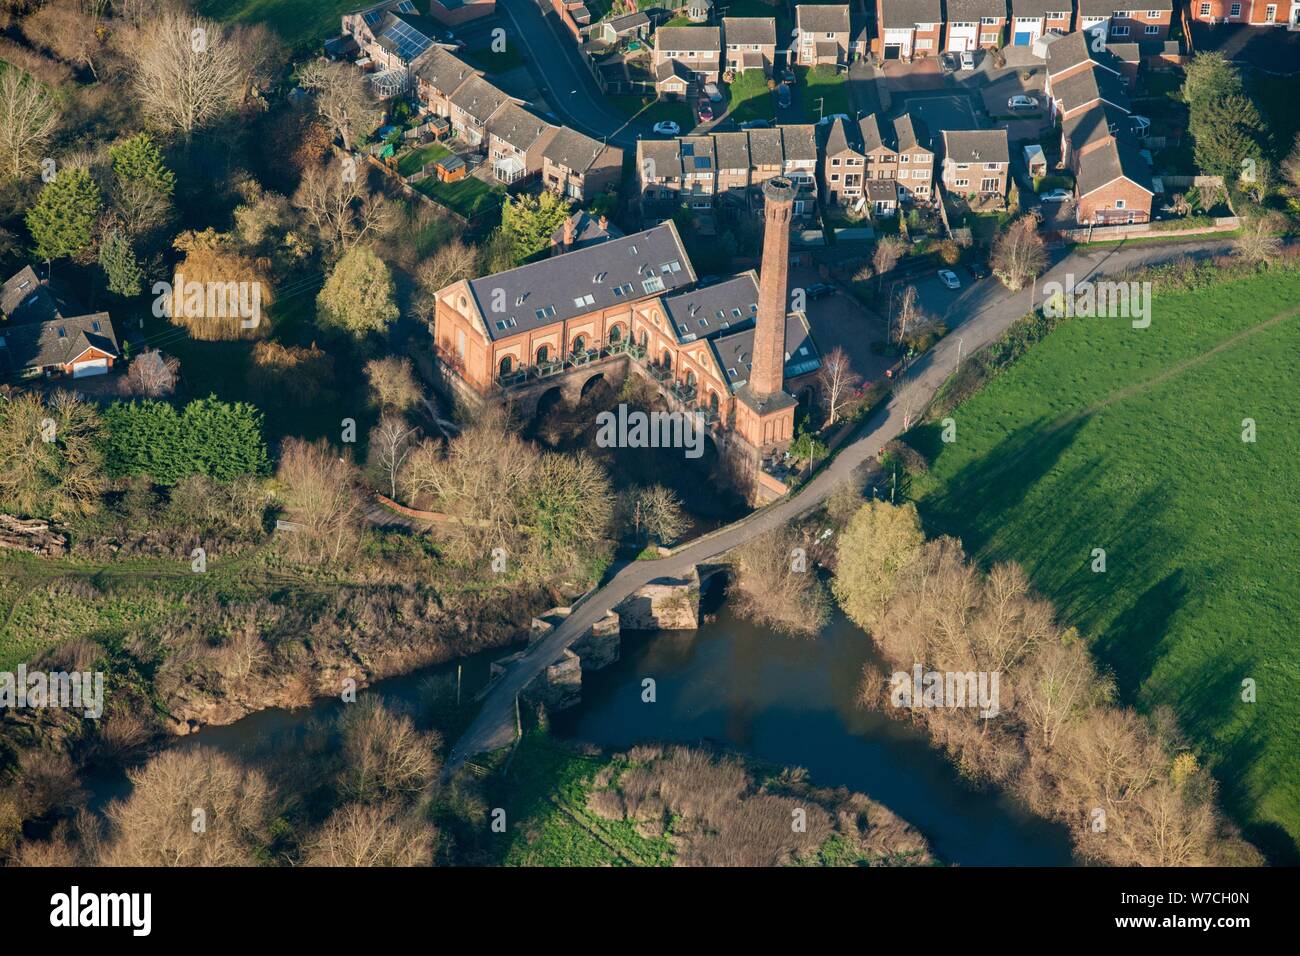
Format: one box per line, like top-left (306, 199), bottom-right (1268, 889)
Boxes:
top-left (0, 265), bottom-right (121, 378)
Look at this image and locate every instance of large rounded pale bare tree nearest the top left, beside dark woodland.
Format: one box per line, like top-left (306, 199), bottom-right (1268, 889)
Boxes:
top-left (126, 7), bottom-right (257, 143)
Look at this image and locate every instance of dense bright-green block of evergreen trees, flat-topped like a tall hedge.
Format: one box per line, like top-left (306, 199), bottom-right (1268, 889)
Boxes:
top-left (104, 395), bottom-right (270, 485)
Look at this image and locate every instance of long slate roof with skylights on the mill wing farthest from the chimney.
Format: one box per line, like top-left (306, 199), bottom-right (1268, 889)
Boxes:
top-left (468, 220), bottom-right (696, 339)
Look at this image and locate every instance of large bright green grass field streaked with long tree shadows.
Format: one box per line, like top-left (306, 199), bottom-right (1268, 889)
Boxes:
top-left (911, 269), bottom-right (1300, 860)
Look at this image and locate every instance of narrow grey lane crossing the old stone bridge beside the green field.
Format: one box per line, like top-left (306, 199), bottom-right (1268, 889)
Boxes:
top-left (445, 241), bottom-right (1231, 775)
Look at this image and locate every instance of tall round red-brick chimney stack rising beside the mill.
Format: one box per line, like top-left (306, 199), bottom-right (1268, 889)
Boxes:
top-left (749, 176), bottom-right (796, 398)
